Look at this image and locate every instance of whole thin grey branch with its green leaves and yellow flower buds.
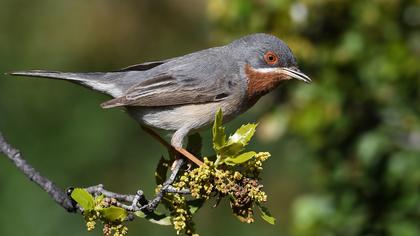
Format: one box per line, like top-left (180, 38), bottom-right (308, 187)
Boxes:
top-left (0, 110), bottom-right (275, 235)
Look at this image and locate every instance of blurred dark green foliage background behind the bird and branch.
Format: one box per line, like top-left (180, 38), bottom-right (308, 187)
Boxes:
top-left (0, 0), bottom-right (420, 236)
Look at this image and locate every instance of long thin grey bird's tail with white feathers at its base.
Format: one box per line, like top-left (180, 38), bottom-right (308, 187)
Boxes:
top-left (8, 70), bottom-right (127, 97)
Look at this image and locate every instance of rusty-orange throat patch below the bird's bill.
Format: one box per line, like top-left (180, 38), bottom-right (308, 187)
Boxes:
top-left (245, 64), bottom-right (289, 106)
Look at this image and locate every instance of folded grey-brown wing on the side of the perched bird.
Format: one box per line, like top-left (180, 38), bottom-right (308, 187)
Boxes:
top-left (102, 51), bottom-right (243, 108)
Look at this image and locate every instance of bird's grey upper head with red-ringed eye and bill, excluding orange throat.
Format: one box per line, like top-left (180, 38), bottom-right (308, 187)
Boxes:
top-left (228, 33), bottom-right (311, 82)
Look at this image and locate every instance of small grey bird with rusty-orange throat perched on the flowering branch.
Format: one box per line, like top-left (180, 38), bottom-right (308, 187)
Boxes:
top-left (9, 33), bottom-right (311, 165)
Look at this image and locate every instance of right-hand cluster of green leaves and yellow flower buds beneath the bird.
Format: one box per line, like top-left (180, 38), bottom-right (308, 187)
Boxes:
top-left (167, 110), bottom-right (275, 233)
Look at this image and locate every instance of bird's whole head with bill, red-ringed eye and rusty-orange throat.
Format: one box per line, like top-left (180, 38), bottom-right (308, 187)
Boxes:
top-left (230, 34), bottom-right (311, 98)
